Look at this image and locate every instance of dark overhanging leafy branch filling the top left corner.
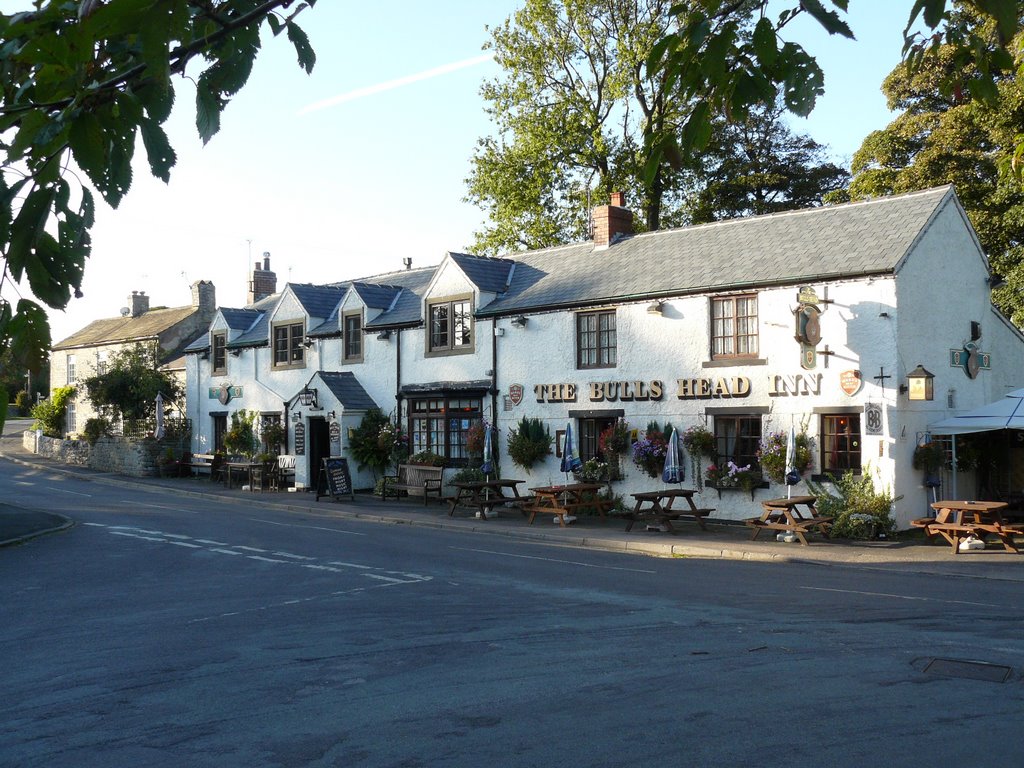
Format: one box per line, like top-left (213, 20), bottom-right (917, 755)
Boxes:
top-left (0, 0), bottom-right (316, 434)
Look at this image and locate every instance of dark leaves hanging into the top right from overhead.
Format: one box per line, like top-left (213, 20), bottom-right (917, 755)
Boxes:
top-left (645, 0), bottom-right (1024, 178)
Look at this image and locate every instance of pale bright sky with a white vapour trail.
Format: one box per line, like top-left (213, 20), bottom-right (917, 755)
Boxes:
top-left (19, 0), bottom-right (911, 342)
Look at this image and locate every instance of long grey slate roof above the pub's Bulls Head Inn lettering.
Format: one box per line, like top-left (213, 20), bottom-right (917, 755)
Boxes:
top-left (477, 186), bottom-right (955, 316)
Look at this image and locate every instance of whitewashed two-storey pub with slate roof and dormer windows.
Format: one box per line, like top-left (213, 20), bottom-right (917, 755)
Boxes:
top-left (187, 186), bottom-right (1024, 527)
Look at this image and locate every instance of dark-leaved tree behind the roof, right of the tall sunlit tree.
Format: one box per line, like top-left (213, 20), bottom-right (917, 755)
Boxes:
top-left (686, 103), bottom-right (850, 223)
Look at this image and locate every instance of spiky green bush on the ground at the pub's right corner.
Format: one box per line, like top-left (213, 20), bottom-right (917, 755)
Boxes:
top-left (807, 467), bottom-right (903, 539)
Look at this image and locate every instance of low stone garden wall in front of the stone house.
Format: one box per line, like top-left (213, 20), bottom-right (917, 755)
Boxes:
top-left (22, 430), bottom-right (184, 477)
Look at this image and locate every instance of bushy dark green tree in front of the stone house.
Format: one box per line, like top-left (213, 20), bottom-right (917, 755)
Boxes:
top-left (81, 344), bottom-right (184, 421)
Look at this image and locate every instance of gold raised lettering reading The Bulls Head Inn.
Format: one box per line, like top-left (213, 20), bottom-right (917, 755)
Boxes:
top-left (528, 374), bottom-right (822, 402)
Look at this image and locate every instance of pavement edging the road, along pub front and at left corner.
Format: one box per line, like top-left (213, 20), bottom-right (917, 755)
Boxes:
top-left (6, 424), bottom-right (1024, 582)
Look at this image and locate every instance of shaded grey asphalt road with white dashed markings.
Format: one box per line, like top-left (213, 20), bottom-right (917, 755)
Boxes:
top-left (0, 442), bottom-right (1024, 768)
